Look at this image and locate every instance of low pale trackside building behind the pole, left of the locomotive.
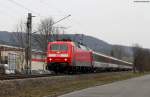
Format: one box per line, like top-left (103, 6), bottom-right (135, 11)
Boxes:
top-left (0, 45), bottom-right (46, 72)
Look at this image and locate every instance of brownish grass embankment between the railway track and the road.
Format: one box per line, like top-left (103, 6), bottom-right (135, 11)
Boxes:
top-left (0, 72), bottom-right (144, 97)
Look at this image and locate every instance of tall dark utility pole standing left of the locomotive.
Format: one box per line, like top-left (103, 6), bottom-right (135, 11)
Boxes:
top-left (25, 13), bottom-right (33, 74)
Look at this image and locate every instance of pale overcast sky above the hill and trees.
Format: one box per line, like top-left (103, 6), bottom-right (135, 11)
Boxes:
top-left (0, 0), bottom-right (150, 48)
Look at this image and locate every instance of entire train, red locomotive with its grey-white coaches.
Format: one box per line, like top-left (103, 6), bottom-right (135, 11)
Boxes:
top-left (47, 41), bottom-right (132, 73)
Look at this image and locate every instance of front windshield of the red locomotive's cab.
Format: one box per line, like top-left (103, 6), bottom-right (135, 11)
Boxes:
top-left (50, 44), bottom-right (68, 51)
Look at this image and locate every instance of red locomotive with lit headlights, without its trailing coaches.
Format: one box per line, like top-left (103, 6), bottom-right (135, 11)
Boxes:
top-left (47, 41), bottom-right (92, 72)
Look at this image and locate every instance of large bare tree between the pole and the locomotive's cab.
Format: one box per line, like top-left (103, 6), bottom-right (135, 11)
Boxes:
top-left (33, 17), bottom-right (55, 52)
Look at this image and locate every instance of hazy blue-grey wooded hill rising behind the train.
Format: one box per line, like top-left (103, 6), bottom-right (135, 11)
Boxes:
top-left (0, 31), bottom-right (132, 60)
